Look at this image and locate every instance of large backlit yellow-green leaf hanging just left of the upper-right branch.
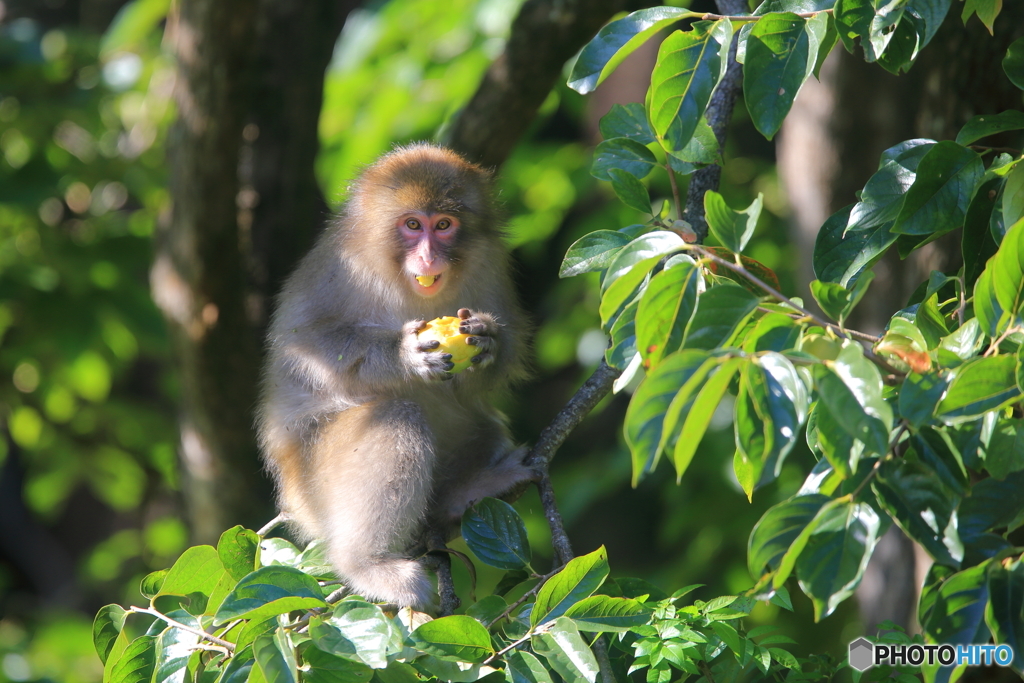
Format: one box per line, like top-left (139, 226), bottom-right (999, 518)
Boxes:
top-left (647, 19), bottom-right (732, 152)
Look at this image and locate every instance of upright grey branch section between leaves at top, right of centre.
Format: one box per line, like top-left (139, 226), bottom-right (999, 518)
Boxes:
top-left (682, 0), bottom-right (748, 244)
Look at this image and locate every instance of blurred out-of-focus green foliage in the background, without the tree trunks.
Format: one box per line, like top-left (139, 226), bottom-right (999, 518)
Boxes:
top-left (0, 0), bottom-right (839, 682)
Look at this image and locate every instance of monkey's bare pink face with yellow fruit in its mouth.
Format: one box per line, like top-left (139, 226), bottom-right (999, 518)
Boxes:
top-left (398, 211), bottom-right (459, 297)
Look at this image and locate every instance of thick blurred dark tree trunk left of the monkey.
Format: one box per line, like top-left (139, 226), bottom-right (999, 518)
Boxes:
top-left (152, 0), bottom-right (352, 542)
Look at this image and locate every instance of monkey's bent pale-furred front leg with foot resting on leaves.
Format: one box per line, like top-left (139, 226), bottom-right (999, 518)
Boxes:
top-left (309, 400), bottom-right (434, 608)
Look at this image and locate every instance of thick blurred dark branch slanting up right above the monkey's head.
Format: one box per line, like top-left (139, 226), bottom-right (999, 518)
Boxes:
top-left (446, 0), bottom-right (633, 168)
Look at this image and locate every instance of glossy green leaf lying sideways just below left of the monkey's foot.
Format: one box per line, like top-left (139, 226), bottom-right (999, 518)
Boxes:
top-left (214, 565), bottom-right (327, 626)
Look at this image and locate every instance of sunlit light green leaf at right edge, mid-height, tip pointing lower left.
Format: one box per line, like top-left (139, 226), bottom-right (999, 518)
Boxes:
top-left (936, 355), bottom-right (1021, 424)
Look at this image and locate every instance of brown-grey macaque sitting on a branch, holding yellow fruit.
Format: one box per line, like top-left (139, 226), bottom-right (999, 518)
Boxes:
top-left (258, 144), bottom-right (537, 608)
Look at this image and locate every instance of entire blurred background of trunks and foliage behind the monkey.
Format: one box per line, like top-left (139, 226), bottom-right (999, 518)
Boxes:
top-left (0, 0), bottom-right (1024, 683)
